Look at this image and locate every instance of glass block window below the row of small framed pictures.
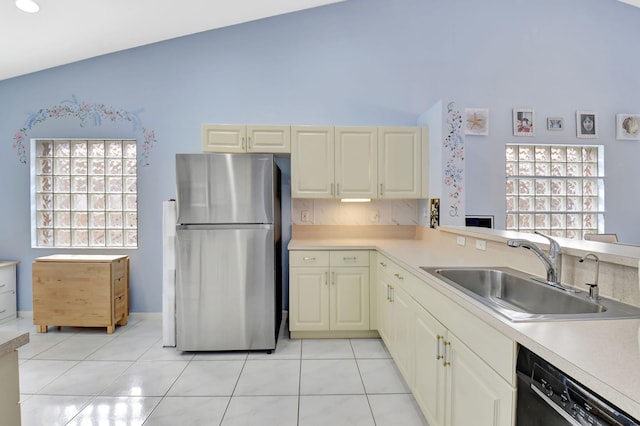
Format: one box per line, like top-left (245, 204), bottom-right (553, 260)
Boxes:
top-left (506, 144), bottom-right (604, 239)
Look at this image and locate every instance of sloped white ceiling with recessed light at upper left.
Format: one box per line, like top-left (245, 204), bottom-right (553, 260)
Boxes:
top-left (0, 0), bottom-right (344, 80)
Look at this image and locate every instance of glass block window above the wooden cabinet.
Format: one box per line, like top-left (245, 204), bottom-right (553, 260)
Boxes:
top-left (31, 139), bottom-right (138, 248)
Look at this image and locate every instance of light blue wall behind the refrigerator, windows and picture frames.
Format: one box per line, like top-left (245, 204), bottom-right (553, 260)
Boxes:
top-left (0, 0), bottom-right (640, 312)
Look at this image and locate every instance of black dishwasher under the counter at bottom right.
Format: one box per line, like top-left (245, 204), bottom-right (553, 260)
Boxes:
top-left (516, 346), bottom-right (640, 426)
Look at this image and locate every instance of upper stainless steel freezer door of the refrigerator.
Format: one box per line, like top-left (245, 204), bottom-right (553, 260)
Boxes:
top-left (176, 154), bottom-right (274, 224)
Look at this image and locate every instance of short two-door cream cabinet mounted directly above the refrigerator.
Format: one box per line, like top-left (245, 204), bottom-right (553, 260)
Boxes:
top-left (202, 124), bottom-right (291, 153)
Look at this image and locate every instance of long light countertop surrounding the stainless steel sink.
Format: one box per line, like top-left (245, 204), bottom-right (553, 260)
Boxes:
top-left (289, 239), bottom-right (640, 419)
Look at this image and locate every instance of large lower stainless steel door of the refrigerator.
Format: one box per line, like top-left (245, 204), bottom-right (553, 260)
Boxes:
top-left (176, 225), bottom-right (279, 351)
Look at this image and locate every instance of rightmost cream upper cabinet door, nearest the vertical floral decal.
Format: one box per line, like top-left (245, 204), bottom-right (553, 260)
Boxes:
top-left (378, 127), bottom-right (422, 198)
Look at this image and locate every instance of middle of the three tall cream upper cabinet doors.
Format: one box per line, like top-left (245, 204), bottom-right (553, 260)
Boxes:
top-left (335, 127), bottom-right (378, 198)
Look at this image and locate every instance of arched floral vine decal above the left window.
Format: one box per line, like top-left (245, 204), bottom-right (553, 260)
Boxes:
top-left (13, 95), bottom-right (156, 166)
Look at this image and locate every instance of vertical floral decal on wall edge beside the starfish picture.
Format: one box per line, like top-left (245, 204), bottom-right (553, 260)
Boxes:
top-left (442, 102), bottom-right (464, 217)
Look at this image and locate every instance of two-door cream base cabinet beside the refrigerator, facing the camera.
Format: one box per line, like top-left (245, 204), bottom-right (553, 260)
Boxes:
top-left (289, 250), bottom-right (370, 332)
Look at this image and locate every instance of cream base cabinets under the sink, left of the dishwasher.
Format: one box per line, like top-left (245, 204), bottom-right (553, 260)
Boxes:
top-left (377, 255), bottom-right (515, 426)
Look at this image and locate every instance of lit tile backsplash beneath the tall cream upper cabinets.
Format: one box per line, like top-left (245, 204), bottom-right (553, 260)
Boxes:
top-left (291, 199), bottom-right (419, 225)
